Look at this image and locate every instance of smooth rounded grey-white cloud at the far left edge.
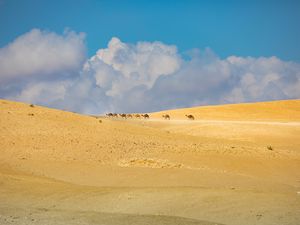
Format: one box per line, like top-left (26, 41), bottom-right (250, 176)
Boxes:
top-left (0, 29), bottom-right (85, 83)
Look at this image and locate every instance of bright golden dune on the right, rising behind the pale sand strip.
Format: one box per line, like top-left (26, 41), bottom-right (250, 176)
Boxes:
top-left (151, 99), bottom-right (300, 121)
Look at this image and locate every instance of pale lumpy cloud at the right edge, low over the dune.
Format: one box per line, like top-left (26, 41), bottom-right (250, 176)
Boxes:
top-left (222, 56), bottom-right (300, 102)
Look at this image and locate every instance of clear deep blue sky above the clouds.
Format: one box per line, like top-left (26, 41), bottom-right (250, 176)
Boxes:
top-left (0, 0), bottom-right (300, 61)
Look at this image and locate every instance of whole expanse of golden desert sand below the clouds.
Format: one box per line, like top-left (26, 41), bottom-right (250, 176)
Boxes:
top-left (0, 100), bottom-right (300, 225)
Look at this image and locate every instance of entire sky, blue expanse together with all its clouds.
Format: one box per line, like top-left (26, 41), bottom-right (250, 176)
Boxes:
top-left (0, 0), bottom-right (300, 114)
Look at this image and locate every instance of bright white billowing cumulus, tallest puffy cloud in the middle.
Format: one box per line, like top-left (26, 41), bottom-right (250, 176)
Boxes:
top-left (84, 37), bottom-right (181, 96)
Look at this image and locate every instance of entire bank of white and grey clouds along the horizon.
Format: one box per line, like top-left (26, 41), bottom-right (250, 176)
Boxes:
top-left (0, 29), bottom-right (300, 114)
